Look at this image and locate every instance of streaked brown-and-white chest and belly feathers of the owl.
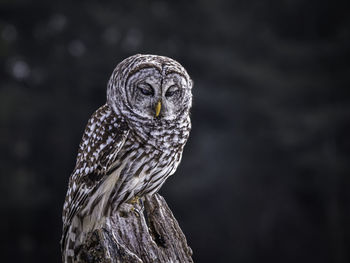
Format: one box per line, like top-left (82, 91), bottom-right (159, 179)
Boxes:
top-left (109, 115), bottom-right (190, 205)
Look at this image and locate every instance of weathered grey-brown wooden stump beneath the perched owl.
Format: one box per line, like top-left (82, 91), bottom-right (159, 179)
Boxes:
top-left (77, 194), bottom-right (193, 263)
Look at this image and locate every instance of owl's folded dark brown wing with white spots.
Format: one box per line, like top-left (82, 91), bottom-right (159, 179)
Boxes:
top-left (61, 104), bottom-right (128, 250)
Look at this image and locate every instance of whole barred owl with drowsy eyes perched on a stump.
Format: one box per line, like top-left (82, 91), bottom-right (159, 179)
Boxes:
top-left (61, 55), bottom-right (192, 262)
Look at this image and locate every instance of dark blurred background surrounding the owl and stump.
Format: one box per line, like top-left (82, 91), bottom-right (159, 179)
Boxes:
top-left (0, 0), bottom-right (350, 263)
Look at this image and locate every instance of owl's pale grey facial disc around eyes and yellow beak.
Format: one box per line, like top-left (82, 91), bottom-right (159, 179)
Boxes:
top-left (126, 68), bottom-right (188, 120)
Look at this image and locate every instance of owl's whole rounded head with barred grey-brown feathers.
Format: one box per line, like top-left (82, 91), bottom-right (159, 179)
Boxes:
top-left (107, 54), bottom-right (192, 123)
